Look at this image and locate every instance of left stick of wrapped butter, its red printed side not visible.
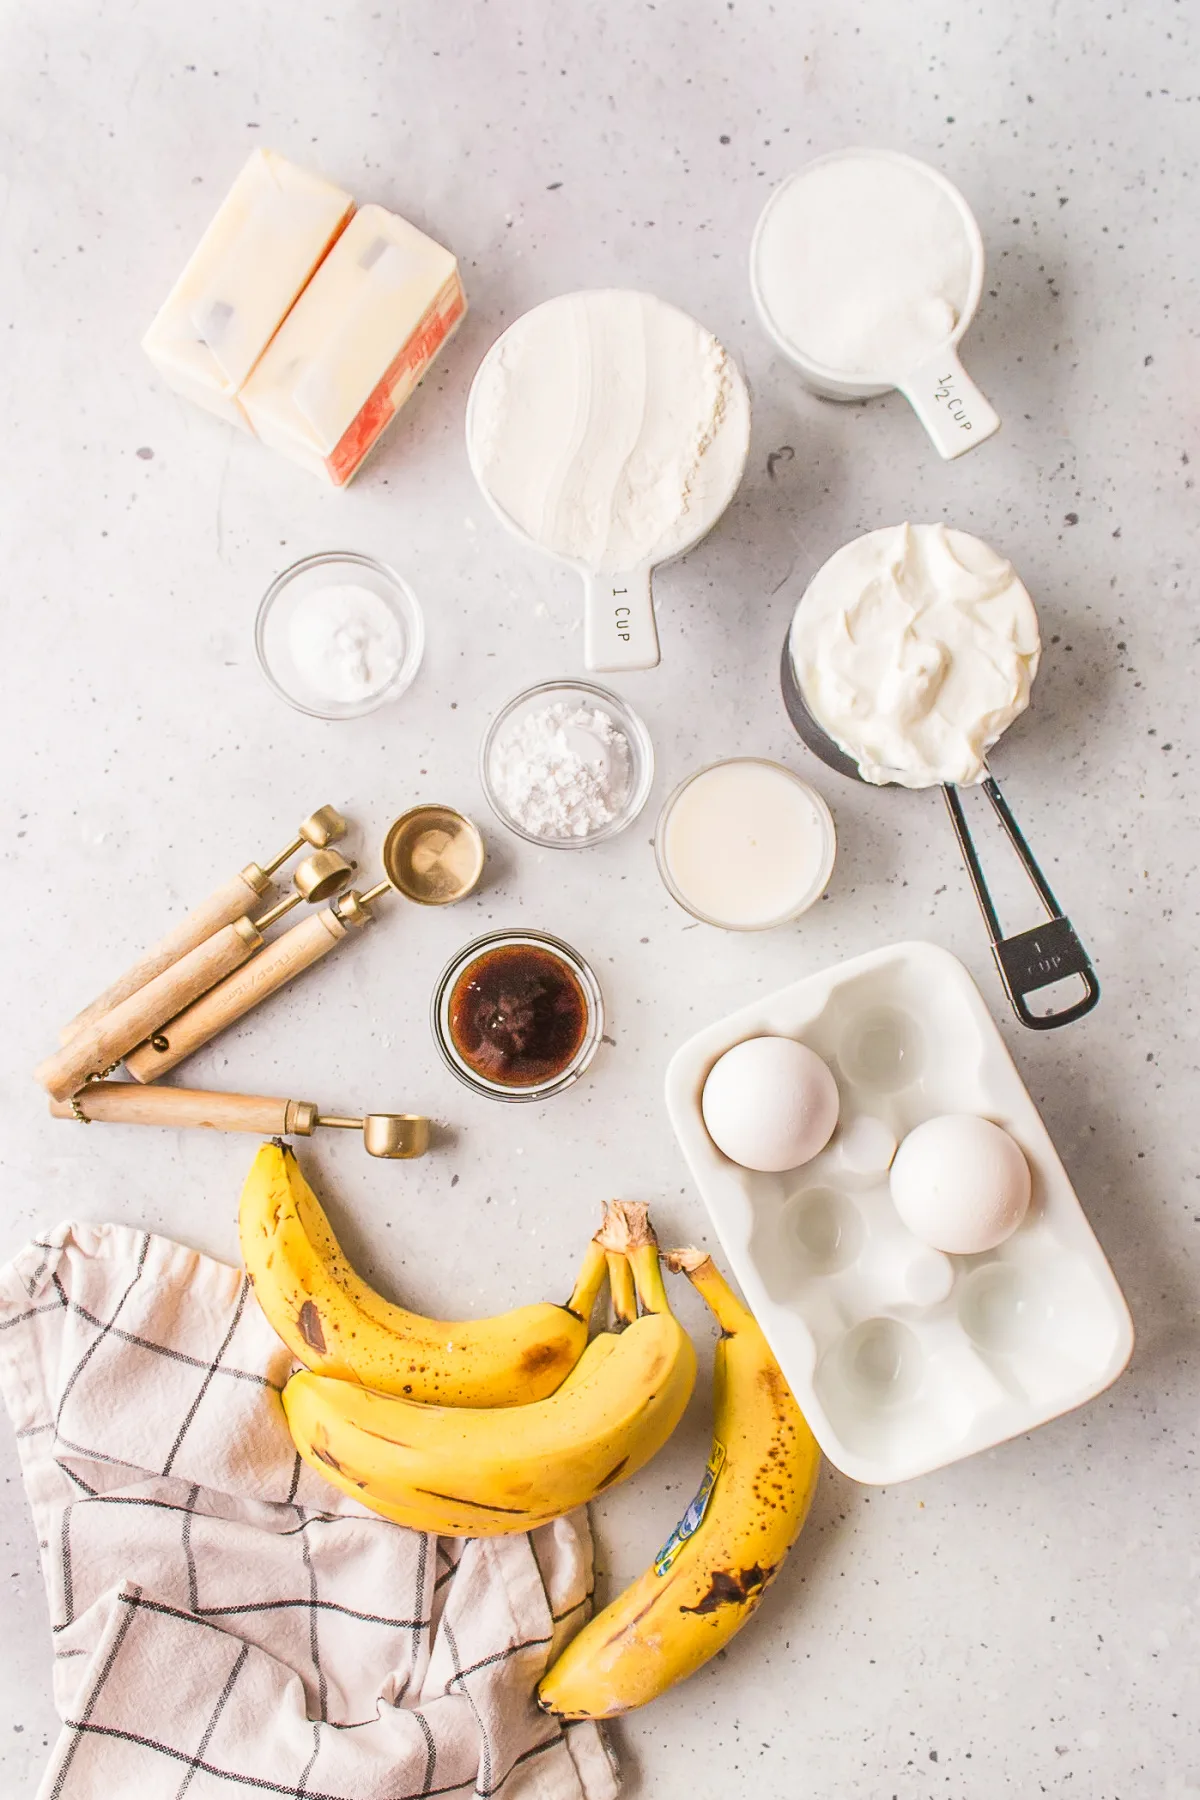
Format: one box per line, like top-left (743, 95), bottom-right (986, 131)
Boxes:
top-left (142, 149), bottom-right (354, 430)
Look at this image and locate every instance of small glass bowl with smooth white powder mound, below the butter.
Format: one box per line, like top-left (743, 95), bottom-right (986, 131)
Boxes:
top-left (254, 551), bottom-right (425, 718)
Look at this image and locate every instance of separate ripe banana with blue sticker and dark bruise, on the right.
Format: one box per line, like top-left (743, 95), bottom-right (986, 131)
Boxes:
top-left (538, 1249), bottom-right (820, 1719)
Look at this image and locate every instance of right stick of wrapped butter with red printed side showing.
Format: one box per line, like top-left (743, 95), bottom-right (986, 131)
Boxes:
top-left (241, 205), bottom-right (466, 488)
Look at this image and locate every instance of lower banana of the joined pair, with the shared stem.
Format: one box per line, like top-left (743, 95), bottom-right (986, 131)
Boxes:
top-left (282, 1202), bottom-right (696, 1537)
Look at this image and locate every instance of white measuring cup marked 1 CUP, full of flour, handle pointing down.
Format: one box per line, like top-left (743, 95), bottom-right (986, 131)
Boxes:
top-left (466, 288), bottom-right (750, 671)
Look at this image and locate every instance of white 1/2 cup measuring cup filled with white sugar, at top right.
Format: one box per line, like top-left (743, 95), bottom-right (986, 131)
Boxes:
top-left (750, 148), bottom-right (1000, 459)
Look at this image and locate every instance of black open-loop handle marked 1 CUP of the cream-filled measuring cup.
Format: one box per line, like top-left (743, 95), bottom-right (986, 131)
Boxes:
top-left (943, 776), bottom-right (1099, 1031)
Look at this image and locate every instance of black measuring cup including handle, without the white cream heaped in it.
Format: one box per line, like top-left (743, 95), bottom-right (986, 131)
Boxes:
top-left (779, 630), bottom-right (1099, 1031)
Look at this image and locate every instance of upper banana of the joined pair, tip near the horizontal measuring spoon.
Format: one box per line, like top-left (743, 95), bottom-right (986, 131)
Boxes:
top-left (237, 1141), bottom-right (604, 1408)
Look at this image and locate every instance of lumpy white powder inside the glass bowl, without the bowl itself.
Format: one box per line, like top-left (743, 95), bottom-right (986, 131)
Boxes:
top-left (488, 700), bottom-right (633, 842)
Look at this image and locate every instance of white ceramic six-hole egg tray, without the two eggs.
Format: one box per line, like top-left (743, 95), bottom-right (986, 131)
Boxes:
top-left (666, 943), bottom-right (1133, 1483)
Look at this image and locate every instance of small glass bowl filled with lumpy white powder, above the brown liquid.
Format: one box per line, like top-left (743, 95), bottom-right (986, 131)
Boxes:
top-left (479, 680), bottom-right (655, 850)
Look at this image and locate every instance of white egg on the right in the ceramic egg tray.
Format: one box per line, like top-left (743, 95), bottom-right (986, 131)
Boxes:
top-left (891, 1112), bottom-right (1031, 1256)
